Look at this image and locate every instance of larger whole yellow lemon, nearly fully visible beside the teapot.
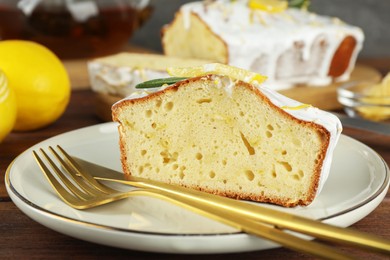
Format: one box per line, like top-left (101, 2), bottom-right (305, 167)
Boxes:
top-left (0, 40), bottom-right (71, 131)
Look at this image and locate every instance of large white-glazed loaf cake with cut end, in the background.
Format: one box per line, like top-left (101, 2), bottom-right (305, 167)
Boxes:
top-left (162, 0), bottom-right (364, 89)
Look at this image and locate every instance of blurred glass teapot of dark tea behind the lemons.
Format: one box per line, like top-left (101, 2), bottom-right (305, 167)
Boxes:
top-left (0, 0), bottom-right (152, 59)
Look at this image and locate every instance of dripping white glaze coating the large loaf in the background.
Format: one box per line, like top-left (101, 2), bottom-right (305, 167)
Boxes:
top-left (180, 0), bottom-right (364, 89)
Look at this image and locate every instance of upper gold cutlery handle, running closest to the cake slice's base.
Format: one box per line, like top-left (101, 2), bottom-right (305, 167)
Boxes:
top-left (98, 176), bottom-right (390, 255)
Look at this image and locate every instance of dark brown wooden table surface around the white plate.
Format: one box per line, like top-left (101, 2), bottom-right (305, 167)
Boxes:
top-left (0, 59), bottom-right (390, 260)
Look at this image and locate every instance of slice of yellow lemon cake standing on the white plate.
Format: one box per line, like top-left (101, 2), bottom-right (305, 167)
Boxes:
top-left (112, 65), bottom-right (342, 207)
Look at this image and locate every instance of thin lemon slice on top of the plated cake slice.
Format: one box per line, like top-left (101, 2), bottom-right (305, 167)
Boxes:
top-left (167, 63), bottom-right (267, 84)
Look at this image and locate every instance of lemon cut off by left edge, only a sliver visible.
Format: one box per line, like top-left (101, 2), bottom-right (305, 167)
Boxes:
top-left (0, 70), bottom-right (16, 142)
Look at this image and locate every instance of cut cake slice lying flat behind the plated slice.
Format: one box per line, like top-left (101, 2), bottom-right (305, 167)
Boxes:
top-left (88, 52), bottom-right (208, 97)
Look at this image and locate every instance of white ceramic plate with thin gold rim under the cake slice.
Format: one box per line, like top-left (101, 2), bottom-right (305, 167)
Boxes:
top-left (5, 123), bottom-right (389, 254)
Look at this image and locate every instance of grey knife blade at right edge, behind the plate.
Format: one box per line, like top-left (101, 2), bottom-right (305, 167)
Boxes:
top-left (332, 112), bottom-right (390, 136)
